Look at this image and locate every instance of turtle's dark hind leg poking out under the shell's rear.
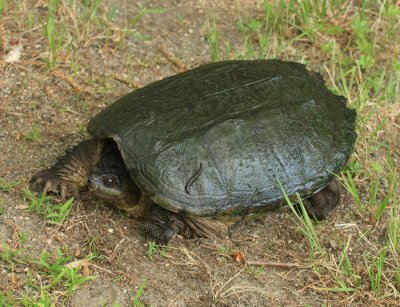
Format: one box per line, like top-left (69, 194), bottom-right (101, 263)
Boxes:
top-left (303, 178), bottom-right (341, 221)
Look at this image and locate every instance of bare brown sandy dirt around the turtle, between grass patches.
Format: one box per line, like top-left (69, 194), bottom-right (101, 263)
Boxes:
top-left (0, 0), bottom-right (396, 306)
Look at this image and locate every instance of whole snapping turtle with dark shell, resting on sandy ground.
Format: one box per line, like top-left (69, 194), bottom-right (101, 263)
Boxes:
top-left (31, 60), bottom-right (356, 243)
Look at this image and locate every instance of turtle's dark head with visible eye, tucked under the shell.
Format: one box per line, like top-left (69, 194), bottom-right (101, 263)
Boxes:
top-left (88, 149), bottom-right (141, 215)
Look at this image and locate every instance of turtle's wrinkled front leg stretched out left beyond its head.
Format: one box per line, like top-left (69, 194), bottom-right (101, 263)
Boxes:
top-left (29, 139), bottom-right (104, 201)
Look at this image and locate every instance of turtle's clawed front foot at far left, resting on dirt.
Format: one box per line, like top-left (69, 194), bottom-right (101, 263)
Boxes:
top-left (29, 168), bottom-right (78, 202)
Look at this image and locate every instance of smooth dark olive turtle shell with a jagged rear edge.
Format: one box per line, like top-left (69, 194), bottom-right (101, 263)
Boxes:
top-left (88, 60), bottom-right (356, 217)
